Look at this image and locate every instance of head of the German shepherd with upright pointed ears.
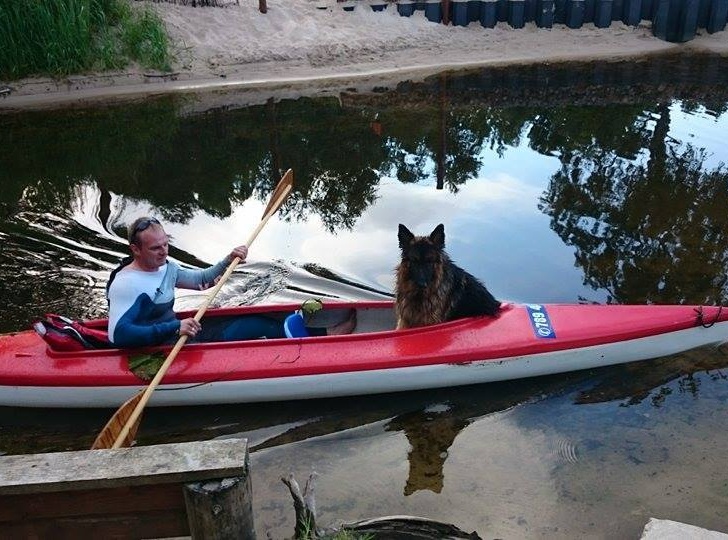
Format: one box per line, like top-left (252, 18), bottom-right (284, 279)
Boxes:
top-left (397, 223), bottom-right (445, 288)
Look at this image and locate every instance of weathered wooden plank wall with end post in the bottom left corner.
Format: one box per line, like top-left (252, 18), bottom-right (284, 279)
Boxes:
top-left (0, 439), bottom-right (254, 540)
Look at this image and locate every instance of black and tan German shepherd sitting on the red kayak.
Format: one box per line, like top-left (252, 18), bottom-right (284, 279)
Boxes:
top-left (395, 223), bottom-right (500, 329)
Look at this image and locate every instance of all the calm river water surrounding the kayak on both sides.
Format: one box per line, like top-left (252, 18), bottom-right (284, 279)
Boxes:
top-left (0, 53), bottom-right (728, 538)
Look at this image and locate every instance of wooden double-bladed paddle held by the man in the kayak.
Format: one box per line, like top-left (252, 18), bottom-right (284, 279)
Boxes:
top-left (91, 169), bottom-right (293, 450)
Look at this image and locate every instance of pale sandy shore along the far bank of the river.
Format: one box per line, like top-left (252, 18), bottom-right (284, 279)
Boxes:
top-left (0, 0), bottom-right (728, 109)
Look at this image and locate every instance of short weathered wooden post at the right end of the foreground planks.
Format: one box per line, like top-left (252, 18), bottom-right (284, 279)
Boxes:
top-left (184, 455), bottom-right (255, 540)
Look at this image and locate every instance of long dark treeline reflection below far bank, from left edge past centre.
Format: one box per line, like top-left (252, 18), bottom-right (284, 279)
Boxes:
top-left (0, 91), bottom-right (528, 231)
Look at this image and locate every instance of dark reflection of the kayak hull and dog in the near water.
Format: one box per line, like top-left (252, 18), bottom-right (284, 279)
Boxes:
top-left (0, 372), bottom-right (584, 472)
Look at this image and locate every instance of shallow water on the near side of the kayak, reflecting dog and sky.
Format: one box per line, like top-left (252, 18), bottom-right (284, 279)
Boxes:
top-left (0, 350), bottom-right (728, 538)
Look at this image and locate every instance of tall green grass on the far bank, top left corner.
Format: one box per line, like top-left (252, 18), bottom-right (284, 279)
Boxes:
top-left (0, 0), bottom-right (170, 81)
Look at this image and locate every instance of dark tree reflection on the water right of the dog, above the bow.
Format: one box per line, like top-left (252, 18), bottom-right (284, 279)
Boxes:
top-left (534, 101), bottom-right (728, 303)
